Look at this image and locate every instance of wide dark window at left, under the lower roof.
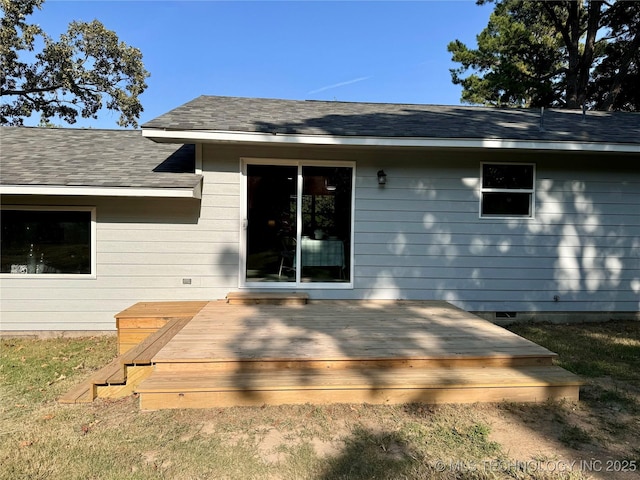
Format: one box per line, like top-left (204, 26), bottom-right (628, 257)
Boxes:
top-left (0, 207), bottom-right (95, 275)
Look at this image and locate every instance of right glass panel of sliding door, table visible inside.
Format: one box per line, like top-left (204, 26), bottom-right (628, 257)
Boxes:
top-left (299, 166), bottom-right (353, 283)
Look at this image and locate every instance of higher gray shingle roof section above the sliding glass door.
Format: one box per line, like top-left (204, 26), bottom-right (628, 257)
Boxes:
top-left (142, 96), bottom-right (640, 144)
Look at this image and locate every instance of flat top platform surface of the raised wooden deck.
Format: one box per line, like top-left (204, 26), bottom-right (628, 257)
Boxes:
top-left (153, 301), bottom-right (554, 363)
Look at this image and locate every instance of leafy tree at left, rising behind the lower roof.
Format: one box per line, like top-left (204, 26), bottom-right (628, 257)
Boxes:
top-left (0, 0), bottom-right (149, 127)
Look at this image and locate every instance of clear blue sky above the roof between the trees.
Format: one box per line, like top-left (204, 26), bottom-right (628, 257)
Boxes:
top-left (26, 0), bottom-right (492, 128)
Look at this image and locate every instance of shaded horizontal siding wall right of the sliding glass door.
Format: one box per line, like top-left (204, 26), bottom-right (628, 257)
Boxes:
top-left (354, 154), bottom-right (640, 311)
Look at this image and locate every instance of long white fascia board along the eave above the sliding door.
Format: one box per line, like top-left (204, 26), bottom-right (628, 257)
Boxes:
top-left (142, 129), bottom-right (640, 153)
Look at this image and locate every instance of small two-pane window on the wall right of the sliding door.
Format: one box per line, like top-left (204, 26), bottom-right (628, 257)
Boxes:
top-left (480, 163), bottom-right (535, 217)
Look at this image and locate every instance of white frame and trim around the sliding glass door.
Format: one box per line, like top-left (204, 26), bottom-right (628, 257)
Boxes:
top-left (238, 157), bottom-right (356, 290)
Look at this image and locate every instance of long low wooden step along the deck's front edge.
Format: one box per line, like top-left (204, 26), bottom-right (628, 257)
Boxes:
top-left (136, 366), bottom-right (582, 410)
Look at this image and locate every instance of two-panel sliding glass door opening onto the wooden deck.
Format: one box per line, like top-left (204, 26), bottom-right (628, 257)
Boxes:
top-left (244, 162), bottom-right (353, 287)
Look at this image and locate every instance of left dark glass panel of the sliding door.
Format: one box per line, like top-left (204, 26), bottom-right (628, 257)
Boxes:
top-left (245, 165), bottom-right (298, 282)
